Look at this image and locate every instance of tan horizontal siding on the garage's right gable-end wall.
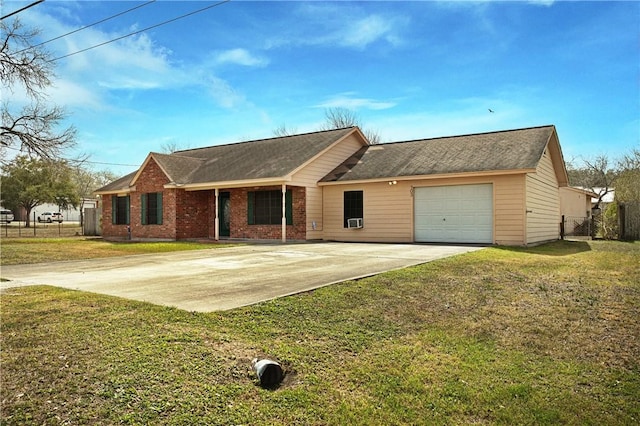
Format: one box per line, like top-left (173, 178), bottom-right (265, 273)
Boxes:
top-left (526, 151), bottom-right (560, 244)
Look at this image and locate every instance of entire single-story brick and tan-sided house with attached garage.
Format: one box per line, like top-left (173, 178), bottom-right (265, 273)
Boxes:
top-left (96, 126), bottom-right (567, 245)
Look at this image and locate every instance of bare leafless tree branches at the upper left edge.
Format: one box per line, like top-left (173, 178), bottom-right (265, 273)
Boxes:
top-left (0, 19), bottom-right (76, 159)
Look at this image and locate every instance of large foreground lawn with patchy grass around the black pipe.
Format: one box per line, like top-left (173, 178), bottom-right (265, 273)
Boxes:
top-left (0, 242), bottom-right (640, 425)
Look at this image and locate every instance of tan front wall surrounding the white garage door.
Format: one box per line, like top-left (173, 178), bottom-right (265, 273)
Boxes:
top-left (323, 175), bottom-right (525, 245)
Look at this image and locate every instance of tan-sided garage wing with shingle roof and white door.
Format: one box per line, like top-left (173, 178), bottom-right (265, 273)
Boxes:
top-left (318, 126), bottom-right (568, 245)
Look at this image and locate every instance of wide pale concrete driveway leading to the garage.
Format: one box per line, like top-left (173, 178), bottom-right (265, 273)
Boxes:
top-left (0, 243), bottom-right (480, 312)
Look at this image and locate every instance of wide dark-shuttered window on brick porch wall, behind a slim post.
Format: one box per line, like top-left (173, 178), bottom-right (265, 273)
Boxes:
top-left (247, 190), bottom-right (293, 225)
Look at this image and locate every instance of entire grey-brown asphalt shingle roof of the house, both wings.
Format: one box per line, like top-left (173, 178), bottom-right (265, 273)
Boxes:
top-left (96, 126), bottom-right (555, 192)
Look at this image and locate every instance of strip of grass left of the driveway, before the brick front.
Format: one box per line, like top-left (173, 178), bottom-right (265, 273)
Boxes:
top-left (0, 237), bottom-right (235, 265)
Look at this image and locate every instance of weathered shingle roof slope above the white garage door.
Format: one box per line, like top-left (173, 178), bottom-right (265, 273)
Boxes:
top-left (322, 126), bottom-right (554, 182)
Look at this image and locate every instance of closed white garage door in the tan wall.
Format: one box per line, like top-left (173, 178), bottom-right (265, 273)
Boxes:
top-left (414, 184), bottom-right (493, 244)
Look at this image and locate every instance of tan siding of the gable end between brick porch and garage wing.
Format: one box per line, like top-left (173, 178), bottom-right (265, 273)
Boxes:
top-left (290, 135), bottom-right (363, 240)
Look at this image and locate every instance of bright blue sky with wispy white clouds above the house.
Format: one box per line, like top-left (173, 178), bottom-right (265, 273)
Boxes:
top-left (2, 0), bottom-right (640, 174)
